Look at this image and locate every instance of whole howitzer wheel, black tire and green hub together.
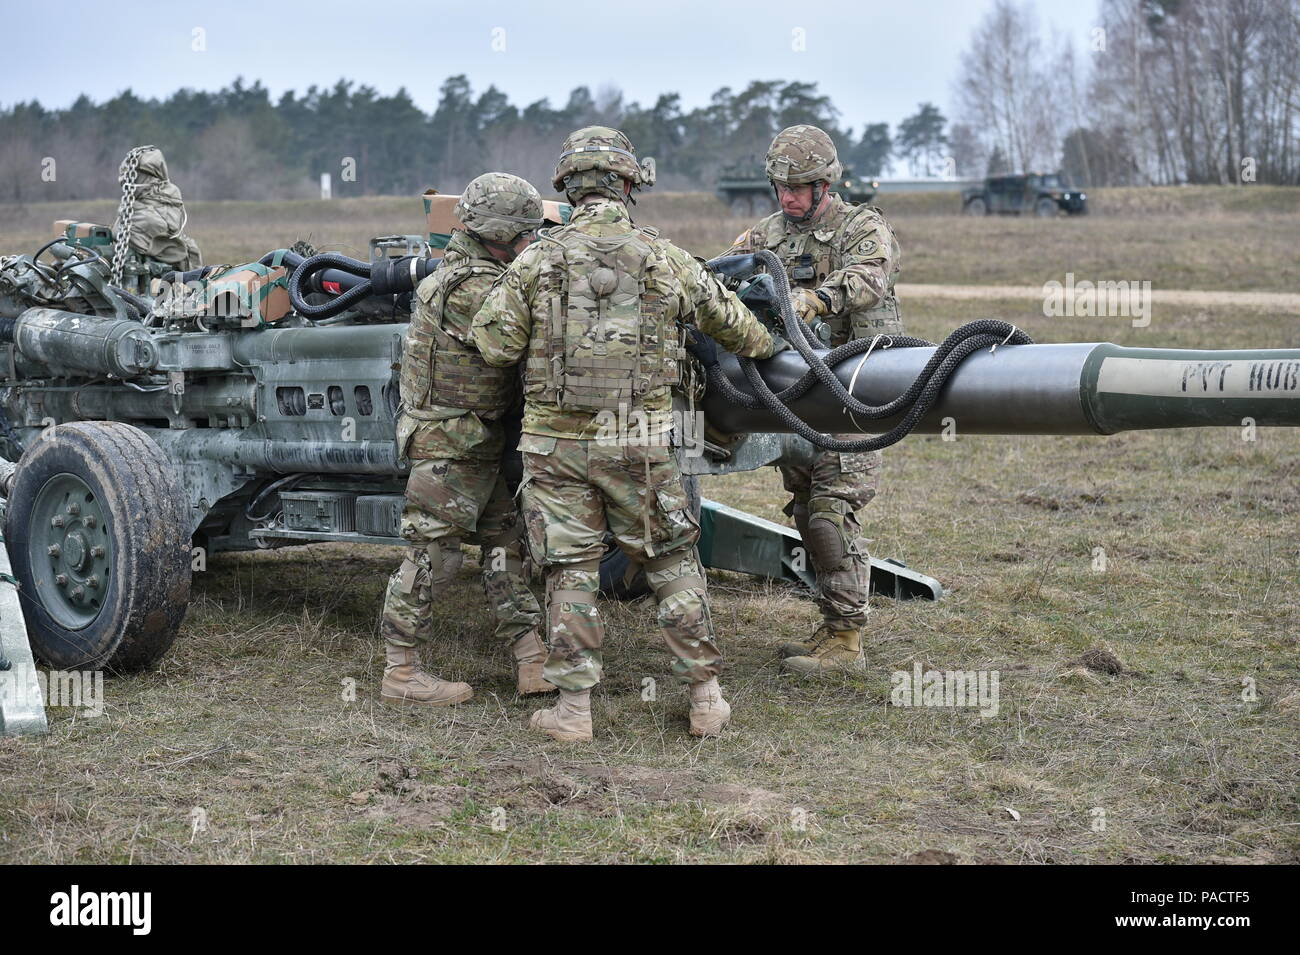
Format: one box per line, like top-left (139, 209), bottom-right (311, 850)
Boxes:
top-left (5, 421), bottom-right (190, 672)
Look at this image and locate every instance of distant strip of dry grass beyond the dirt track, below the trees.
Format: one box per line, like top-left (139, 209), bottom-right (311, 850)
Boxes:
top-left (0, 186), bottom-right (1300, 291)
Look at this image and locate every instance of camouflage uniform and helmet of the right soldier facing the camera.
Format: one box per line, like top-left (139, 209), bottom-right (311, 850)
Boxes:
top-left (729, 126), bottom-right (904, 630)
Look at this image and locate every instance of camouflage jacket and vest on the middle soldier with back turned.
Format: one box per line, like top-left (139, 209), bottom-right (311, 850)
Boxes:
top-left (473, 199), bottom-right (775, 438)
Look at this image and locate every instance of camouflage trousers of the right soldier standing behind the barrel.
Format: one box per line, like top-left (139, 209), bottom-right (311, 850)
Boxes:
top-left (781, 444), bottom-right (881, 630)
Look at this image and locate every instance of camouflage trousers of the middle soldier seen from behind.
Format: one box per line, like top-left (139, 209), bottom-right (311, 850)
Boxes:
top-left (519, 434), bottom-right (722, 690)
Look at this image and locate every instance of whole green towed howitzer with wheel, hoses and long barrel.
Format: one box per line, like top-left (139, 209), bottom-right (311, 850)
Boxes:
top-left (0, 207), bottom-right (1300, 712)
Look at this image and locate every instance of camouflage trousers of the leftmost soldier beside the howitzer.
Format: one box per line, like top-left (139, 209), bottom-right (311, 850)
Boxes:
top-left (380, 459), bottom-right (542, 647)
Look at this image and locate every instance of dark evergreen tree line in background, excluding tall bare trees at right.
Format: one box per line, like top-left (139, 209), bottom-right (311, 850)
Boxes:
top-left (0, 75), bottom-right (943, 201)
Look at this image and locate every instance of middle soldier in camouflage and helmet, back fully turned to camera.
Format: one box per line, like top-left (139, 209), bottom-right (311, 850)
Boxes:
top-left (473, 126), bottom-right (776, 741)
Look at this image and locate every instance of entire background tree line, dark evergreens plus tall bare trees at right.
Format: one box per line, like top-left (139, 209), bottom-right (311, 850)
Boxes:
top-left (0, 0), bottom-right (1300, 201)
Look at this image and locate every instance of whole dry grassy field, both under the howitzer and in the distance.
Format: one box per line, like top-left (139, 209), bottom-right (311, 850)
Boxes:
top-left (0, 188), bottom-right (1300, 863)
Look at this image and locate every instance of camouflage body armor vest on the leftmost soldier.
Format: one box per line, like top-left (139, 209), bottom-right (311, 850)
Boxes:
top-left (402, 259), bottom-right (515, 417)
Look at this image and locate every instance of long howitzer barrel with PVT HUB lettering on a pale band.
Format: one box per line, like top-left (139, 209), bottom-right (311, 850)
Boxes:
top-left (702, 342), bottom-right (1300, 434)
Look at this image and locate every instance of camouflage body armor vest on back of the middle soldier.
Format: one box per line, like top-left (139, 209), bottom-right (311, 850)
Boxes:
top-left (528, 229), bottom-right (684, 412)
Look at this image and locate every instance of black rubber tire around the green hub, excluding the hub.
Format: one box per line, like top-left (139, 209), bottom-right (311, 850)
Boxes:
top-left (4, 421), bottom-right (190, 673)
